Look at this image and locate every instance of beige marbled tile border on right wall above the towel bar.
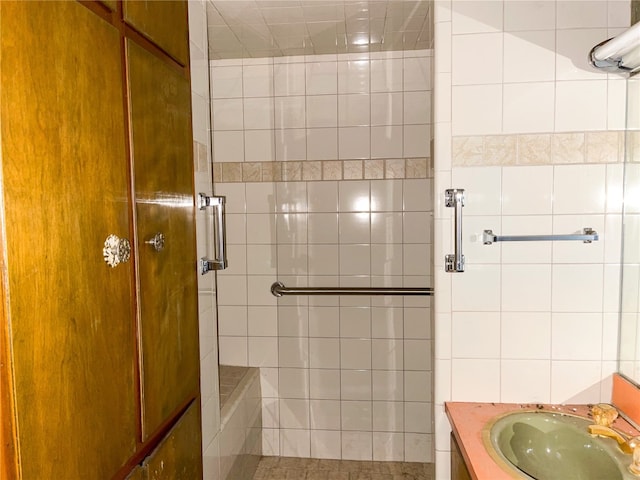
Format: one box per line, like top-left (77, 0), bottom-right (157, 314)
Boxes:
top-left (452, 131), bottom-right (624, 166)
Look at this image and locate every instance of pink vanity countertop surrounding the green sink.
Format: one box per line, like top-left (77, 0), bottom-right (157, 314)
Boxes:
top-left (445, 402), bottom-right (638, 480)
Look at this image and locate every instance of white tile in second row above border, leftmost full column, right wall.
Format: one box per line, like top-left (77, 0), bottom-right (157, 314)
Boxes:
top-left (452, 33), bottom-right (503, 85)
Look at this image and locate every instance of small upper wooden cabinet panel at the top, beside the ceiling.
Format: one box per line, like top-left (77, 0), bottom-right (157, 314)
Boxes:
top-left (123, 0), bottom-right (189, 66)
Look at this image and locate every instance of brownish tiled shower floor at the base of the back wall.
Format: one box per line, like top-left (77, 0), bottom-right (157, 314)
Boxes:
top-left (253, 457), bottom-right (435, 480)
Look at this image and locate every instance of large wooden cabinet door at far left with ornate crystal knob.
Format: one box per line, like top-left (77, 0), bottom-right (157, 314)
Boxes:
top-left (0, 1), bottom-right (137, 479)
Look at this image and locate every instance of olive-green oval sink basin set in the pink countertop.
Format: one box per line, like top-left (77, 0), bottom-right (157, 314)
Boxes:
top-left (485, 411), bottom-right (639, 480)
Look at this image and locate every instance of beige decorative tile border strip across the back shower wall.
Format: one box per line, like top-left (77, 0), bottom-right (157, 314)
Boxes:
top-left (213, 158), bottom-right (433, 183)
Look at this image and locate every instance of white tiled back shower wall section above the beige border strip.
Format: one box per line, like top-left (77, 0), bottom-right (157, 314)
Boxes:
top-left (211, 50), bottom-right (432, 162)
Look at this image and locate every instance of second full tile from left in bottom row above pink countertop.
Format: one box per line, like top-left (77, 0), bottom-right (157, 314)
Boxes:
top-left (500, 360), bottom-right (551, 403)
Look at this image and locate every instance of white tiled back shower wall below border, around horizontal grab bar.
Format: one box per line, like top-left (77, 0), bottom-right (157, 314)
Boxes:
top-left (216, 171), bottom-right (433, 461)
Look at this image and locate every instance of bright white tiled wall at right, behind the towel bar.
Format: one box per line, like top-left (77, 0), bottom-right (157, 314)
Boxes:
top-left (433, 0), bottom-right (629, 480)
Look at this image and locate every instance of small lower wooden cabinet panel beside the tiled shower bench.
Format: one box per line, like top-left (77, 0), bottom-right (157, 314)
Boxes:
top-left (145, 404), bottom-right (202, 480)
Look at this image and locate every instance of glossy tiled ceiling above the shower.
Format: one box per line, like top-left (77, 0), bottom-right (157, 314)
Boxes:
top-left (207, 0), bottom-right (433, 59)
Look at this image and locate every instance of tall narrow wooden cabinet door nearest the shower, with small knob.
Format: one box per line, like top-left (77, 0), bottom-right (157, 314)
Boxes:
top-left (127, 41), bottom-right (199, 439)
